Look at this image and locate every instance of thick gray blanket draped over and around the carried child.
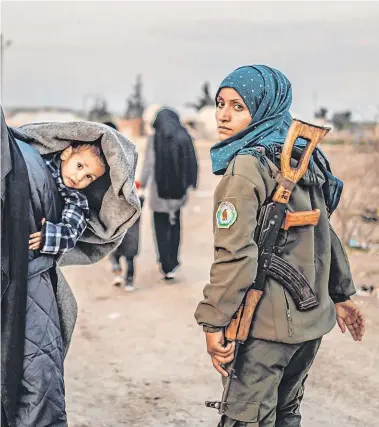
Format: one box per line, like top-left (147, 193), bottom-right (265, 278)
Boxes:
top-left (19, 121), bottom-right (141, 265)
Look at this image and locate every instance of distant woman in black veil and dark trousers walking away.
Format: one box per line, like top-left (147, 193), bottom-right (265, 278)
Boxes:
top-left (140, 108), bottom-right (198, 280)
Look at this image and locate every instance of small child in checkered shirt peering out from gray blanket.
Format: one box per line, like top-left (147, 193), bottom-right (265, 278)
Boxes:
top-left (29, 144), bottom-right (107, 254)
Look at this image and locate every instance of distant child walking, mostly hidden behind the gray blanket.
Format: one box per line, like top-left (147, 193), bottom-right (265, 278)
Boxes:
top-left (109, 181), bottom-right (144, 292)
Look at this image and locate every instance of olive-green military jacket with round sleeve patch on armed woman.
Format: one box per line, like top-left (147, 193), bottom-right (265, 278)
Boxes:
top-left (195, 155), bottom-right (355, 343)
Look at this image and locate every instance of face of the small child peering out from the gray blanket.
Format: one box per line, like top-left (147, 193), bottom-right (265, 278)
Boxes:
top-left (61, 147), bottom-right (105, 190)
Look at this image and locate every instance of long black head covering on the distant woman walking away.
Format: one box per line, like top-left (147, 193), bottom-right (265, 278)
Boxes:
top-left (153, 108), bottom-right (197, 199)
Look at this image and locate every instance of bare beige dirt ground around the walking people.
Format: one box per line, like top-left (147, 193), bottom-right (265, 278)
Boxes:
top-left (64, 141), bottom-right (379, 427)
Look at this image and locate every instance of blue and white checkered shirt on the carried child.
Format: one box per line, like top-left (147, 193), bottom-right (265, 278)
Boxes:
top-left (41, 153), bottom-right (90, 254)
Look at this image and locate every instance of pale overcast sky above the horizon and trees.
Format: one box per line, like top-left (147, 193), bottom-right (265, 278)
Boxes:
top-left (2, 1), bottom-right (379, 120)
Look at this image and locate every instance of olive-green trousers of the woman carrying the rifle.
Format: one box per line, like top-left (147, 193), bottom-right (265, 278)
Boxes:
top-left (218, 338), bottom-right (321, 427)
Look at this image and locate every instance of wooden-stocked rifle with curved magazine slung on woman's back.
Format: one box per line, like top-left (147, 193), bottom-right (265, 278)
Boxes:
top-left (205, 119), bottom-right (330, 415)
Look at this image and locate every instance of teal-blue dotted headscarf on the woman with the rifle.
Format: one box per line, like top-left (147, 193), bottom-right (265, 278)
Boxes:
top-left (211, 65), bottom-right (343, 213)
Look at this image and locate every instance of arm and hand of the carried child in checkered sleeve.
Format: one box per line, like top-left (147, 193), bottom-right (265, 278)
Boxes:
top-left (29, 192), bottom-right (89, 254)
